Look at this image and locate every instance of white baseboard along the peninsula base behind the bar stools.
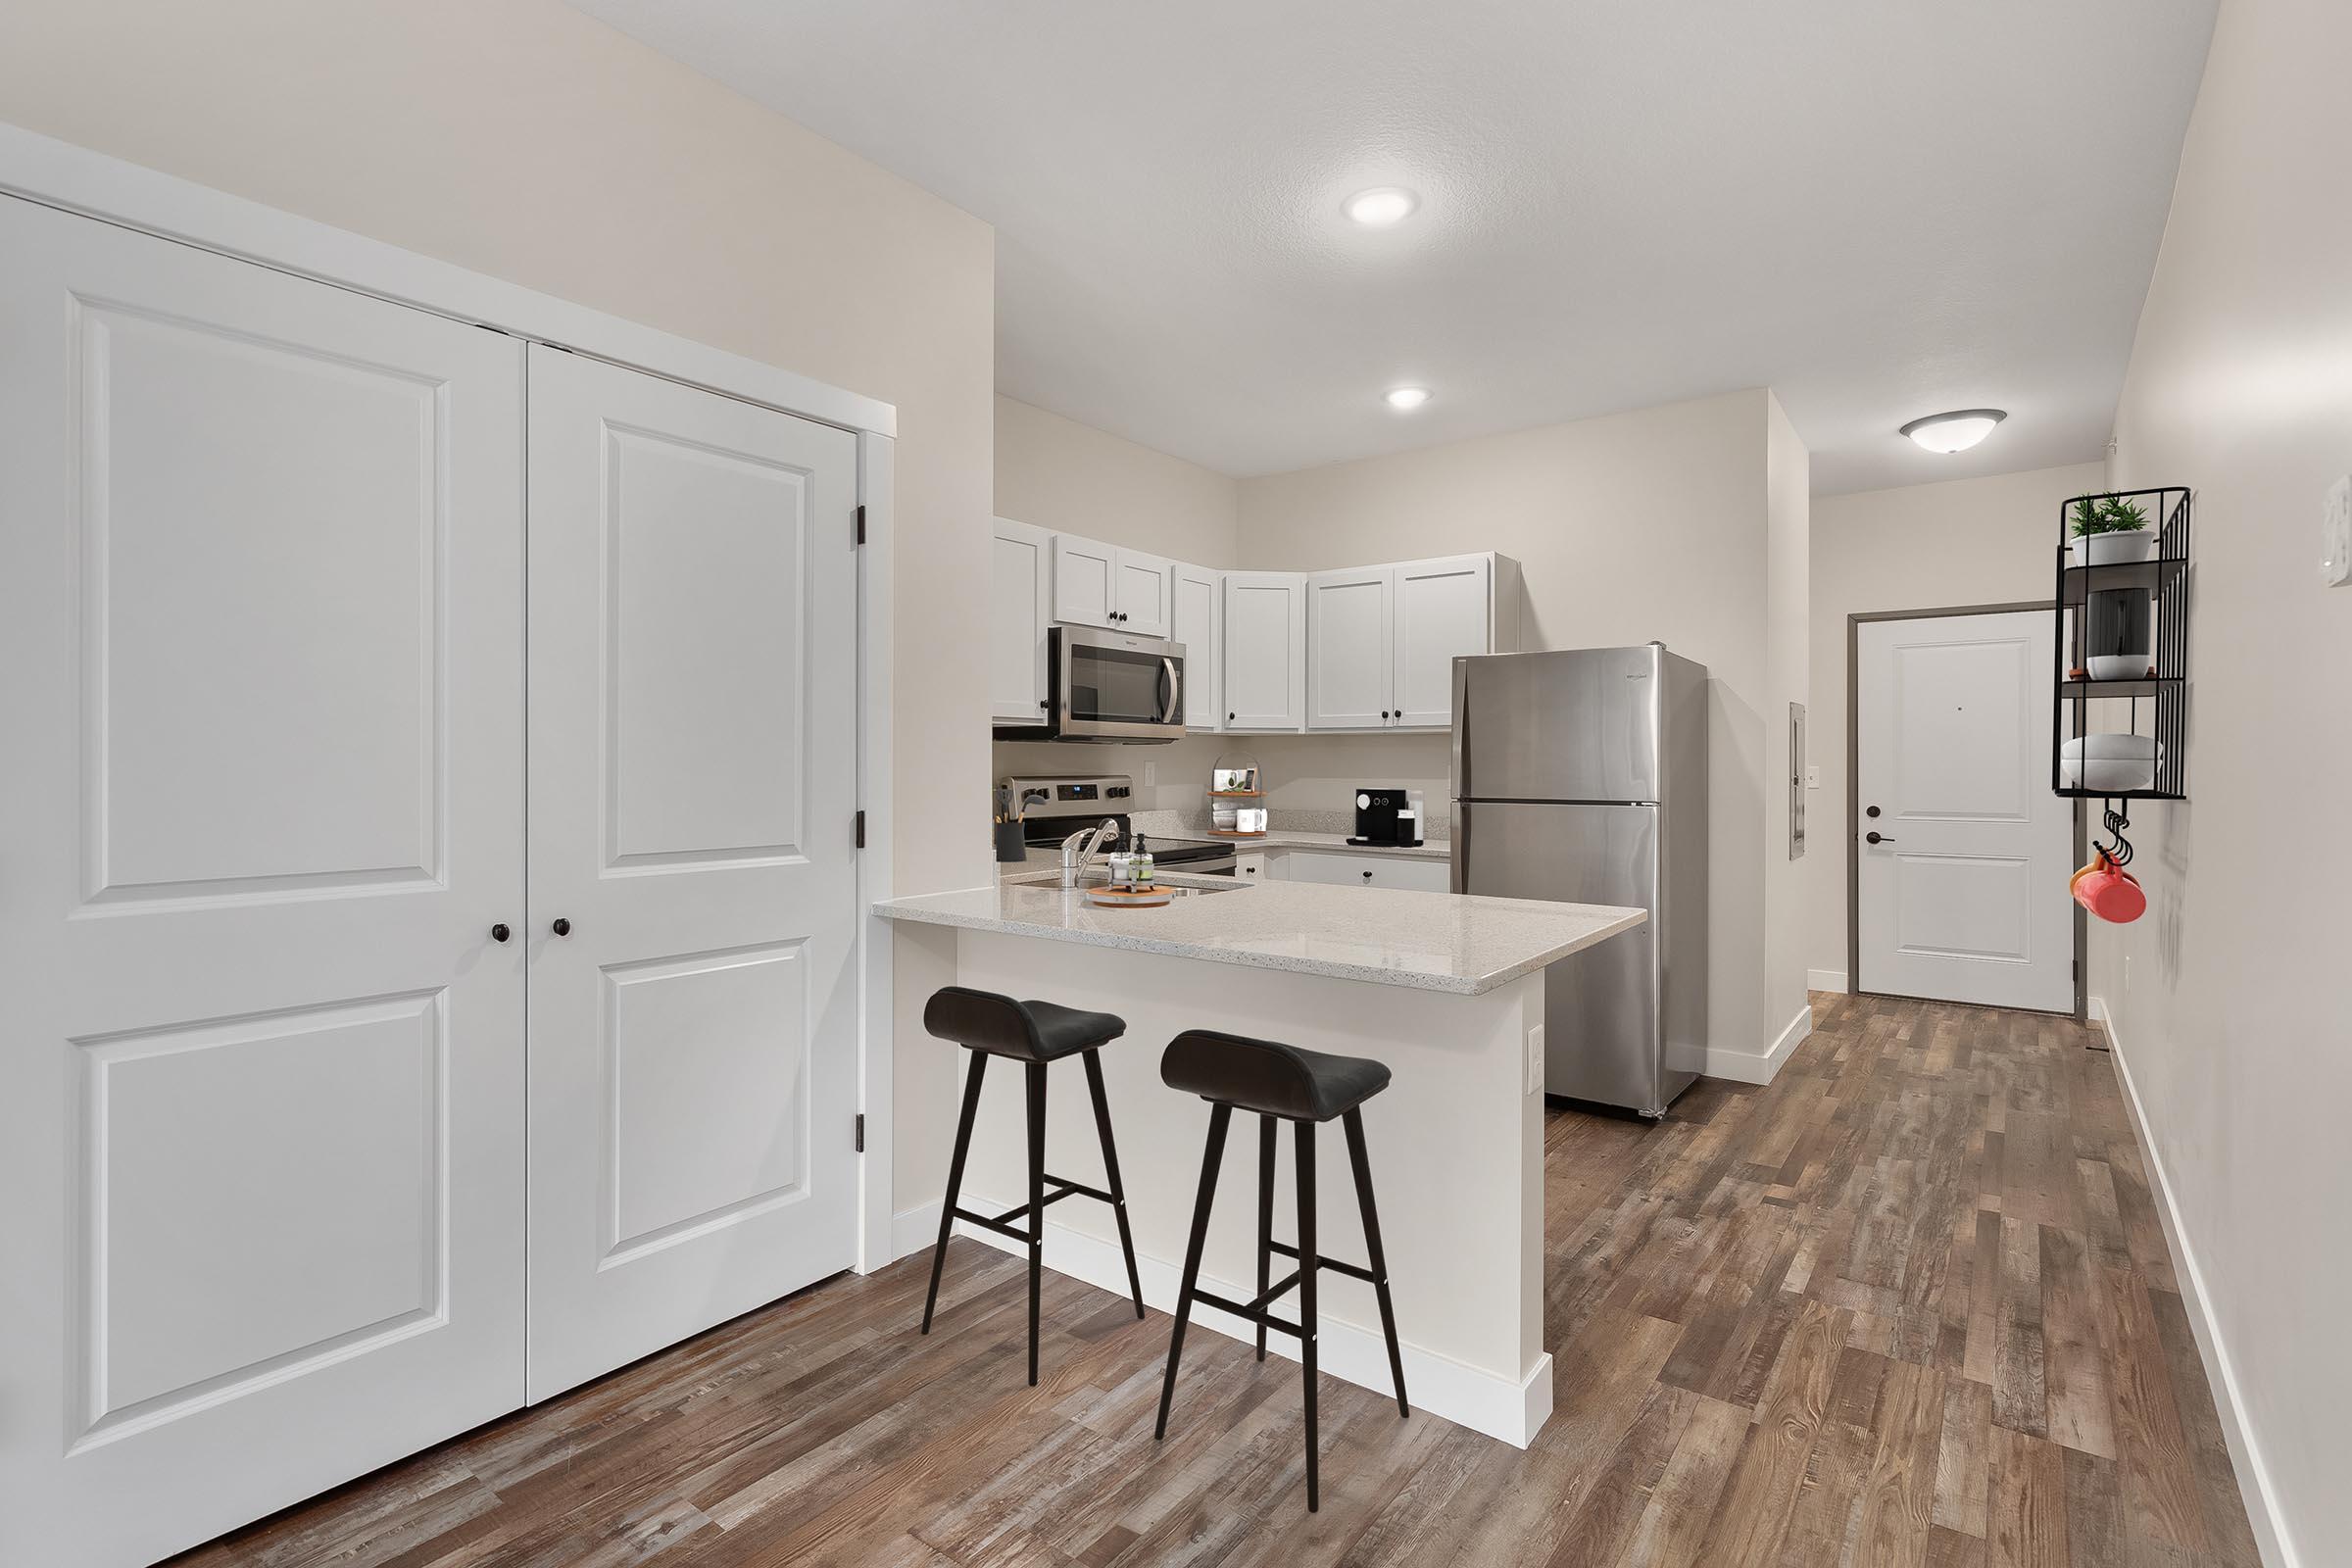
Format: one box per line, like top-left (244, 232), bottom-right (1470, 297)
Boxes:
top-left (945, 1192), bottom-right (1552, 1448)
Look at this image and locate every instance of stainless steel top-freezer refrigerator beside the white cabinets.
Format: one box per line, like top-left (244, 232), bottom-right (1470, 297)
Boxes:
top-left (1453, 642), bottom-right (1707, 1116)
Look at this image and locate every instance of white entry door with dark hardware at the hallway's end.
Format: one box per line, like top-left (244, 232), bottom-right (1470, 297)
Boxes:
top-left (1853, 612), bottom-right (2075, 1013)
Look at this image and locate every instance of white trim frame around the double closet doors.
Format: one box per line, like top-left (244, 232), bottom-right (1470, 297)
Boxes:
top-left (0, 124), bottom-right (899, 1274)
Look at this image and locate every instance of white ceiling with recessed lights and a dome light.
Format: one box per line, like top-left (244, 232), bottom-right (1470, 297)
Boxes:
top-left (574, 0), bottom-right (2216, 491)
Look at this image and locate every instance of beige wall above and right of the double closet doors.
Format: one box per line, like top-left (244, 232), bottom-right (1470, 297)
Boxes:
top-left (0, 0), bottom-right (995, 1206)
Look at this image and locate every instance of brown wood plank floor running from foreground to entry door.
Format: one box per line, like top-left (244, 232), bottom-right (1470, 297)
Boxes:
top-left (166, 997), bottom-right (2258, 1568)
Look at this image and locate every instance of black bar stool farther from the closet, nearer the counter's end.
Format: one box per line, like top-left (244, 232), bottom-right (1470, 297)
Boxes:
top-left (1152, 1030), bottom-right (1413, 1511)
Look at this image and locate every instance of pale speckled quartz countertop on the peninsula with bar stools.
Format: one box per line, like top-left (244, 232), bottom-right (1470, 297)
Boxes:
top-left (875, 874), bottom-right (1648, 997)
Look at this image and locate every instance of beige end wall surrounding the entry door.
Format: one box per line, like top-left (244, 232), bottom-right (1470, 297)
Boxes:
top-left (1799, 464), bottom-right (2105, 985)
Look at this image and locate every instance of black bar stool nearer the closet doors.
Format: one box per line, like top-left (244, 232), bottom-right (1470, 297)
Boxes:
top-left (922, 985), bottom-right (1143, 1382)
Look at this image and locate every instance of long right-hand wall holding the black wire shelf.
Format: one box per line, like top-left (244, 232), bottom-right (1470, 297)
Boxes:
top-left (2091, 0), bottom-right (2352, 1568)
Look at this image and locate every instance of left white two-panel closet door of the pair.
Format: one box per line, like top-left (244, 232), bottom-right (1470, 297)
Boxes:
top-left (0, 197), bottom-right (524, 1568)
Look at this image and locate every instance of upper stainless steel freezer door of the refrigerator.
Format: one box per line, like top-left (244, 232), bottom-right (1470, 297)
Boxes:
top-left (1453, 647), bottom-right (1663, 802)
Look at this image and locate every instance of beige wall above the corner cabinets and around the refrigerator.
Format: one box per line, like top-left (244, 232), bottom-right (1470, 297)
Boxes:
top-left (1242, 390), bottom-right (1806, 1054)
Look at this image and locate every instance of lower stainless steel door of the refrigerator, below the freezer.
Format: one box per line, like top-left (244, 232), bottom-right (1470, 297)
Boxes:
top-left (1453, 802), bottom-right (1680, 1114)
